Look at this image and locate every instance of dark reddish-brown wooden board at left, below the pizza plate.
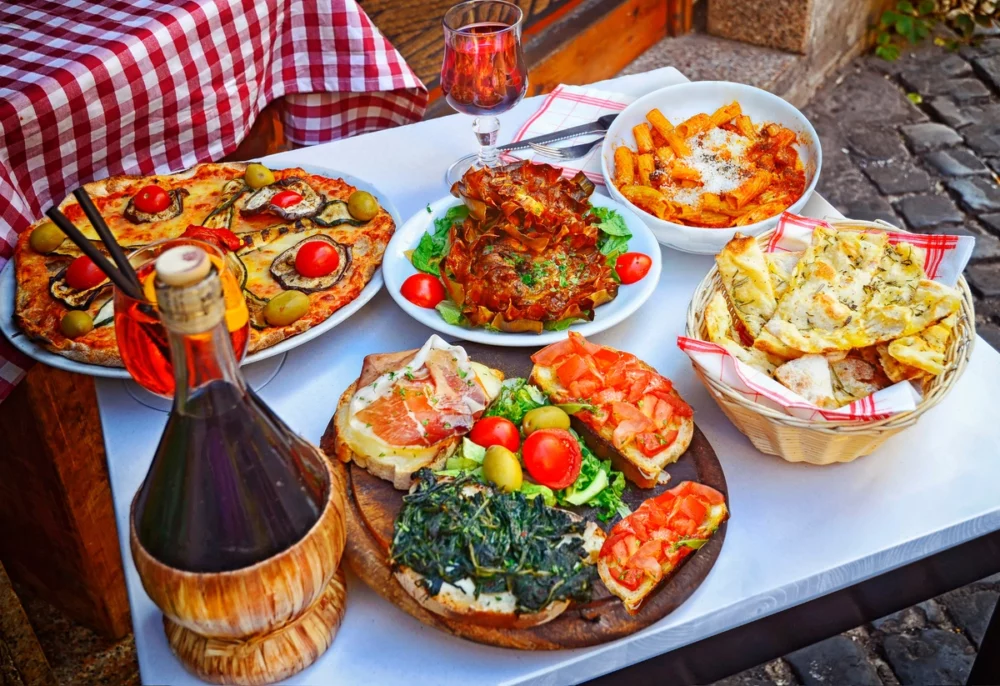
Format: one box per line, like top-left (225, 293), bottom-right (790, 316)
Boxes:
top-left (0, 364), bottom-right (131, 639)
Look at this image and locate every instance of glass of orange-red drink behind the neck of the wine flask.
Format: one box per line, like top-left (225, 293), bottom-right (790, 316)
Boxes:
top-left (114, 238), bottom-right (250, 398)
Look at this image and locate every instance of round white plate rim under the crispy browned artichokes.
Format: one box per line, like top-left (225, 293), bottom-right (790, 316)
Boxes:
top-left (382, 193), bottom-right (662, 347)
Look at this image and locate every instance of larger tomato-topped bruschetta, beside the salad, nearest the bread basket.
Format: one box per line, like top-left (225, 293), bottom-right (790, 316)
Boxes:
top-left (531, 331), bottom-right (694, 488)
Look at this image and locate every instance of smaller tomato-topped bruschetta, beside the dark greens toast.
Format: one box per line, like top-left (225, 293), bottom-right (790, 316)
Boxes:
top-left (597, 481), bottom-right (729, 614)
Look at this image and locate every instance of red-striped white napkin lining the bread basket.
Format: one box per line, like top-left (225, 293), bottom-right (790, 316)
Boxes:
top-left (677, 212), bottom-right (975, 421)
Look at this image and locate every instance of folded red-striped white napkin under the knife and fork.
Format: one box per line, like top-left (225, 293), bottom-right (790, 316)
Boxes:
top-left (502, 85), bottom-right (635, 185)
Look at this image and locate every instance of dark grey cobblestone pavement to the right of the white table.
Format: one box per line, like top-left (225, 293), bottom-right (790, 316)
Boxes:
top-left (716, 37), bottom-right (1000, 686)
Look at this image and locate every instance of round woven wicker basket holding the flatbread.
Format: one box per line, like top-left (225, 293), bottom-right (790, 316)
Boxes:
top-left (685, 219), bottom-right (976, 464)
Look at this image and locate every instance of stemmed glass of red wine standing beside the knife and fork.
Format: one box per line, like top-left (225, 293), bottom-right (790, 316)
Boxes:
top-left (441, 0), bottom-right (528, 183)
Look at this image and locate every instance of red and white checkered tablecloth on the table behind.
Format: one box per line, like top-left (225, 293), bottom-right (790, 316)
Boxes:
top-left (0, 0), bottom-right (427, 400)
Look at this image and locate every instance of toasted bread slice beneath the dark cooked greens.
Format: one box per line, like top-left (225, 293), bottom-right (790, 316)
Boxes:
top-left (395, 490), bottom-right (605, 629)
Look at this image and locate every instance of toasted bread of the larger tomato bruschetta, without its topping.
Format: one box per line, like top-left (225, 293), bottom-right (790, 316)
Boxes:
top-left (530, 360), bottom-right (694, 488)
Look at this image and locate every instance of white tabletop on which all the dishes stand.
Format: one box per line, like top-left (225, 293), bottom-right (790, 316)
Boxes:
top-left (97, 68), bottom-right (1000, 686)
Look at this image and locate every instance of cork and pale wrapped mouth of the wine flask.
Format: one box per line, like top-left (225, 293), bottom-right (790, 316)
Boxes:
top-left (156, 245), bottom-right (226, 334)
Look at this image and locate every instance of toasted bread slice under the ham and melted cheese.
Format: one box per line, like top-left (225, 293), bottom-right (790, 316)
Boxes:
top-left (334, 342), bottom-right (503, 490)
